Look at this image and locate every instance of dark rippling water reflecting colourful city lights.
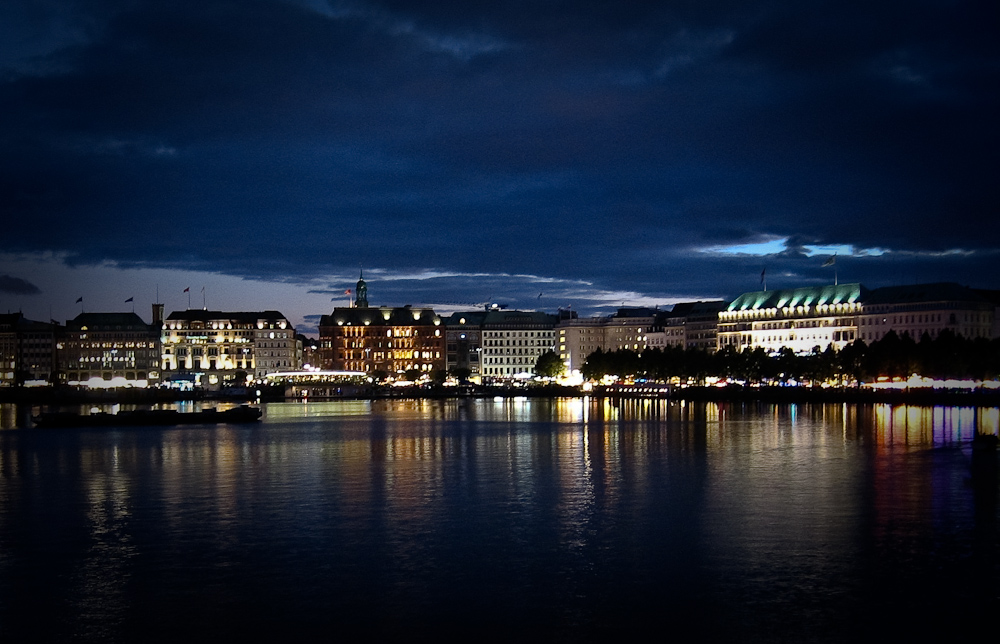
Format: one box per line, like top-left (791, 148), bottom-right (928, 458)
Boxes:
top-left (0, 399), bottom-right (1000, 642)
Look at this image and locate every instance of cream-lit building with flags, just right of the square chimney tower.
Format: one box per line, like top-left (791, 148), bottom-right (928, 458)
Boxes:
top-left (161, 309), bottom-right (299, 388)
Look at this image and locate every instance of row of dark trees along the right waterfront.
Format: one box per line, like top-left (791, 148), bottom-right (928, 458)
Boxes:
top-left (581, 331), bottom-right (1000, 385)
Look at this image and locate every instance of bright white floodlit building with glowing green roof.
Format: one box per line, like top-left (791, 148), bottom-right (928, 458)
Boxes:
top-left (717, 284), bottom-right (868, 353)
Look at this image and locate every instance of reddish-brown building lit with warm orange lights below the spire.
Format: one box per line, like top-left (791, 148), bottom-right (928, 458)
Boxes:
top-left (319, 306), bottom-right (445, 374)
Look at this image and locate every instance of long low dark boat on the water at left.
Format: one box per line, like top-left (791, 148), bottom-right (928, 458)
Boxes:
top-left (31, 405), bottom-right (262, 428)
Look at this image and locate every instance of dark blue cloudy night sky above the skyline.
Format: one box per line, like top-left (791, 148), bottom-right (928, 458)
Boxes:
top-left (0, 0), bottom-right (1000, 332)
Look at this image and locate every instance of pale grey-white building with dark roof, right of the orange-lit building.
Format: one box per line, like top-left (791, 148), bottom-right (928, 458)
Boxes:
top-left (481, 309), bottom-right (558, 380)
